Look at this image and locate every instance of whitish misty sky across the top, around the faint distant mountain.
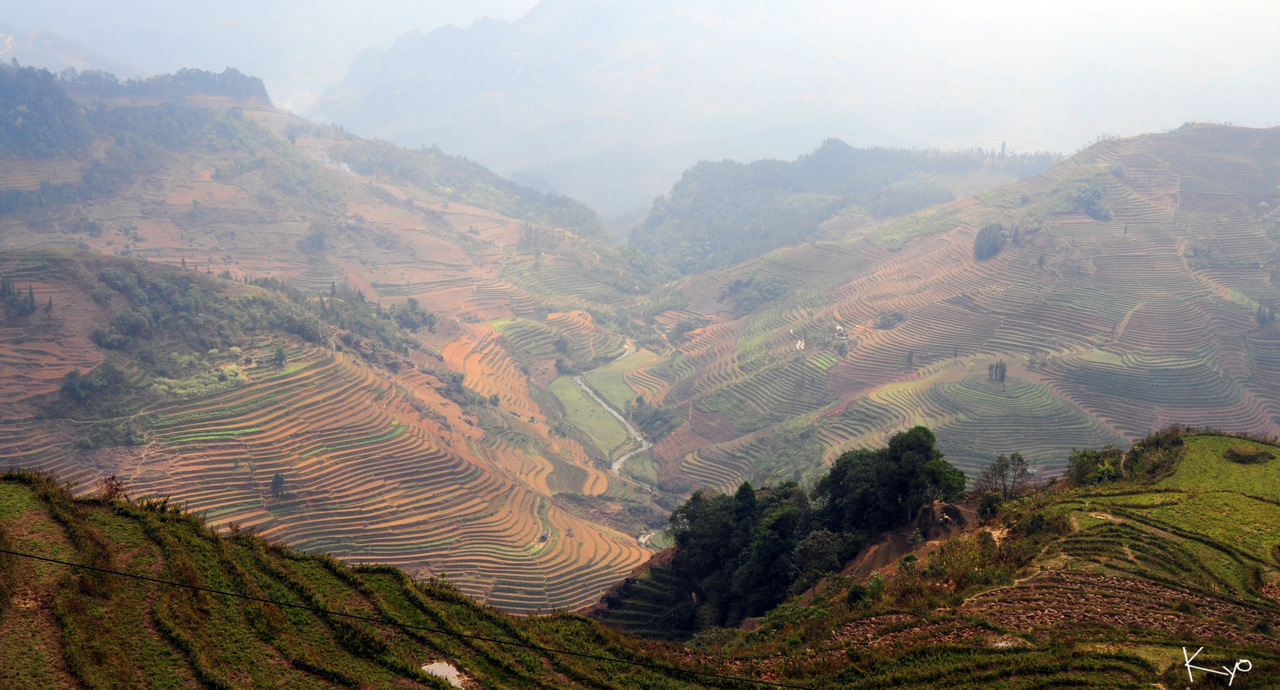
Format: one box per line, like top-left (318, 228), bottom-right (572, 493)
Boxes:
top-left (0, 0), bottom-right (1280, 199)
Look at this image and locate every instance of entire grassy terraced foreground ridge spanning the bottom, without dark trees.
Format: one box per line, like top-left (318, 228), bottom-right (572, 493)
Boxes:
top-left (0, 434), bottom-right (1280, 689)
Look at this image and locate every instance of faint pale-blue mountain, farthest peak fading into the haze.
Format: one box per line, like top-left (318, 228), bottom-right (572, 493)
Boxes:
top-left (310, 0), bottom-right (905, 215)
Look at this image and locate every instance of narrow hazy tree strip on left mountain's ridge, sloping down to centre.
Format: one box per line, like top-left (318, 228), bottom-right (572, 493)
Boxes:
top-left (329, 141), bottom-right (604, 236)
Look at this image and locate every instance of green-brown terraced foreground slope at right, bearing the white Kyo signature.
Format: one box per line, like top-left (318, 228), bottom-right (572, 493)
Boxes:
top-left (595, 433), bottom-right (1280, 687)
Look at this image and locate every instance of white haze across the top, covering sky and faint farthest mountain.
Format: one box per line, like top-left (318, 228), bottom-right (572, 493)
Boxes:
top-left (0, 0), bottom-right (1280, 215)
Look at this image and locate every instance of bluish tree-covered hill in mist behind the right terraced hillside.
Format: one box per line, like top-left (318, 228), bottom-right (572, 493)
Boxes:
top-left (630, 140), bottom-right (1057, 274)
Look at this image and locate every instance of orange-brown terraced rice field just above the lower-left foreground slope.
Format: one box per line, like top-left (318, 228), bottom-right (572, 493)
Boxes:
top-left (0, 349), bottom-right (645, 612)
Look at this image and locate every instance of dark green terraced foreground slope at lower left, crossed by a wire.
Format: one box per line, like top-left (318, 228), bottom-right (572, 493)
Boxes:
top-left (0, 472), bottom-right (736, 689)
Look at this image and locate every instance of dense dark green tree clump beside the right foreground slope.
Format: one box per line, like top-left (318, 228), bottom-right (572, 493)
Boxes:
top-left (667, 426), bottom-right (965, 631)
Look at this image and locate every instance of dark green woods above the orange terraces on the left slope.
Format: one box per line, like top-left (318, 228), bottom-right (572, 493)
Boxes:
top-left (56, 260), bottom-right (435, 422)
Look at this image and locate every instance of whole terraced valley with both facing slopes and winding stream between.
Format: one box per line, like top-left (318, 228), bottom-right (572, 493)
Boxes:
top-left (0, 62), bottom-right (1280, 634)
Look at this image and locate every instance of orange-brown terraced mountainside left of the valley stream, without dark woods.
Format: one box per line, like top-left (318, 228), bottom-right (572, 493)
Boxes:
top-left (0, 70), bottom-right (680, 611)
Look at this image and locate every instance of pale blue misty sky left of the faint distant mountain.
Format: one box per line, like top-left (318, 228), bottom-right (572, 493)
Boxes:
top-left (0, 0), bottom-right (536, 110)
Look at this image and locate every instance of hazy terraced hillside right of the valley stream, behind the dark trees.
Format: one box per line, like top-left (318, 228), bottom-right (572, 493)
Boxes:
top-left (604, 125), bottom-right (1280, 489)
